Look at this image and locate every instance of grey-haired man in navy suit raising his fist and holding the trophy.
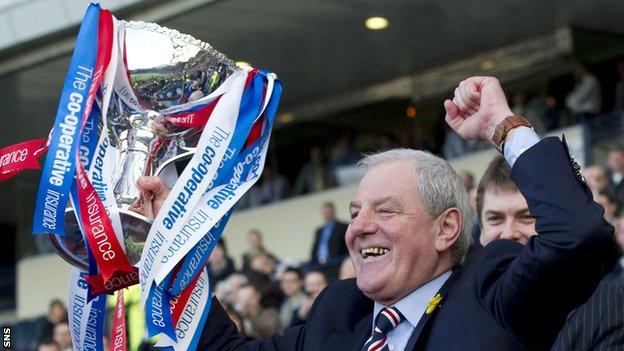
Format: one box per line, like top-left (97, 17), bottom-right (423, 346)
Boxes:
top-left (140, 77), bottom-right (616, 351)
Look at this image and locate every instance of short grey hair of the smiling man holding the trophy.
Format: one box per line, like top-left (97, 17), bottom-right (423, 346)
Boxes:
top-left (359, 149), bottom-right (472, 264)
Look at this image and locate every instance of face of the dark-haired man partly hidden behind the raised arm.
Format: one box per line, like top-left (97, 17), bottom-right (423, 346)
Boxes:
top-left (479, 189), bottom-right (537, 246)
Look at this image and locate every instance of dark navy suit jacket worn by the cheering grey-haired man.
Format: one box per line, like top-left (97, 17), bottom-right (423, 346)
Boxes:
top-left (198, 138), bottom-right (617, 351)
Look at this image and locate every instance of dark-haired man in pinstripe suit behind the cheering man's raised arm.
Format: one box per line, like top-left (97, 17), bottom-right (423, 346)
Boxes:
top-left (477, 156), bottom-right (624, 351)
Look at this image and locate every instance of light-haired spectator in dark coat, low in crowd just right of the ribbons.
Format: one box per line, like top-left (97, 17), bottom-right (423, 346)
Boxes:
top-left (237, 285), bottom-right (280, 339)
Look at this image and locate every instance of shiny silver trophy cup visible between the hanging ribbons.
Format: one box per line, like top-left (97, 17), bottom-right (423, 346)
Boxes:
top-left (50, 21), bottom-right (239, 270)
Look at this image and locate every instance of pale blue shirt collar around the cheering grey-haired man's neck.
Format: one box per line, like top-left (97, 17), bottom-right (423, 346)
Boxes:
top-left (373, 269), bottom-right (451, 327)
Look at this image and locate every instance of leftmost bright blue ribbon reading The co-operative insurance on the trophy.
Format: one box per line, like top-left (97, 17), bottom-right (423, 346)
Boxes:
top-left (33, 4), bottom-right (100, 236)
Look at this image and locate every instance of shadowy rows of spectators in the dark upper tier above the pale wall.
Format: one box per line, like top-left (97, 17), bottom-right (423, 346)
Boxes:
top-left (238, 59), bottom-right (624, 209)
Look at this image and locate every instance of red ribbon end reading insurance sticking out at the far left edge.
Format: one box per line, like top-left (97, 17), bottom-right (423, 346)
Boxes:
top-left (0, 138), bottom-right (47, 182)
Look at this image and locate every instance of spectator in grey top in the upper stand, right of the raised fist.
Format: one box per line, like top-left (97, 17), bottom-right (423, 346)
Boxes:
top-left (565, 62), bottom-right (602, 120)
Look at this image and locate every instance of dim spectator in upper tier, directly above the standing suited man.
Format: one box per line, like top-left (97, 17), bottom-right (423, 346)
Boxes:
top-left (294, 146), bottom-right (336, 195)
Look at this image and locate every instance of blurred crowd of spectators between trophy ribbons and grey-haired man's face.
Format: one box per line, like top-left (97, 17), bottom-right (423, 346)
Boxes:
top-left (209, 220), bottom-right (355, 338)
